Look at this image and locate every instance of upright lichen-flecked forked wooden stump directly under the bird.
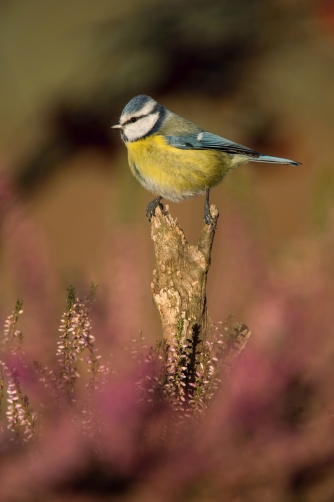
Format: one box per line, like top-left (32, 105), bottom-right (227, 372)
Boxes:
top-left (151, 205), bottom-right (218, 343)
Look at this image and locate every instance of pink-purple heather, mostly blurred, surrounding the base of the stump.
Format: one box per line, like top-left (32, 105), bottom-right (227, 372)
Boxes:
top-left (0, 193), bottom-right (334, 501)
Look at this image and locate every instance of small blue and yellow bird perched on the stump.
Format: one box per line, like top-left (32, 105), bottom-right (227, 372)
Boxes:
top-left (113, 95), bottom-right (300, 225)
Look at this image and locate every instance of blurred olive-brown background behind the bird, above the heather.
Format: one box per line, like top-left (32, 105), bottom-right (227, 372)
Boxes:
top-left (0, 0), bottom-right (334, 350)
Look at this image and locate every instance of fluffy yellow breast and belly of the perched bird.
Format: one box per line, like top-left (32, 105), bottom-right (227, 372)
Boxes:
top-left (126, 134), bottom-right (244, 202)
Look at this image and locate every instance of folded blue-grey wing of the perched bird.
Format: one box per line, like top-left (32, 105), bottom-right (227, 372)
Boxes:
top-left (165, 131), bottom-right (260, 157)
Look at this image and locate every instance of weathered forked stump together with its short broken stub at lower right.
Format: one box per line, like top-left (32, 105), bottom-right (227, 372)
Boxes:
top-left (151, 205), bottom-right (251, 375)
